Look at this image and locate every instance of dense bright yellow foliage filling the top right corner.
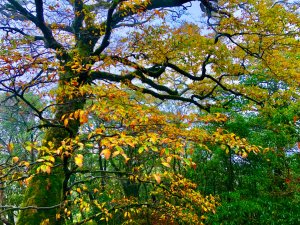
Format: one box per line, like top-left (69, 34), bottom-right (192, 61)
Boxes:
top-left (218, 0), bottom-right (299, 87)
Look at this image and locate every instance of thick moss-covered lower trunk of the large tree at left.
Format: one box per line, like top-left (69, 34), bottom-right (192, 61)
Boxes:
top-left (17, 69), bottom-right (85, 225)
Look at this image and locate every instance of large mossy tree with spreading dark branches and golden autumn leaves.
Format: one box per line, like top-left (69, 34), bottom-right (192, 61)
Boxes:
top-left (0, 0), bottom-right (300, 225)
